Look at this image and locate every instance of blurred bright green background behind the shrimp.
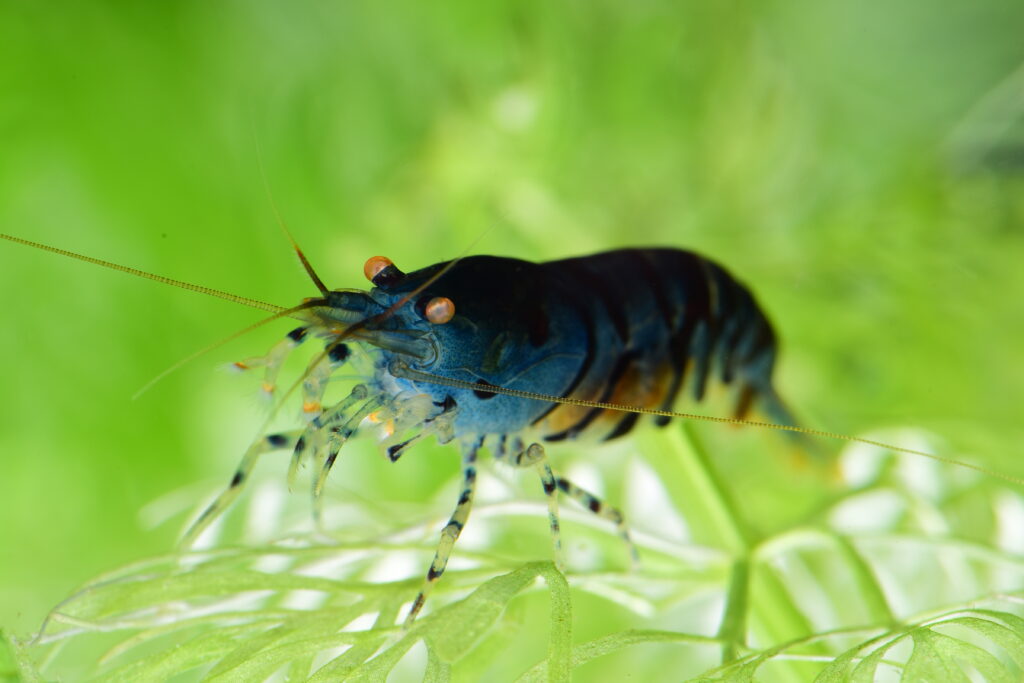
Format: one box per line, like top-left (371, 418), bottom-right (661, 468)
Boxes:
top-left (0, 0), bottom-right (1024, 679)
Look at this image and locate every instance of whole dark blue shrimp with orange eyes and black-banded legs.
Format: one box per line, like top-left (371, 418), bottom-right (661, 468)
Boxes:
top-left (185, 249), bottom-right (793, 624)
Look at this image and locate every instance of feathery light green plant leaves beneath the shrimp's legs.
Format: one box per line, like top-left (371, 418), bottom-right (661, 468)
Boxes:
top-left (14, 423), bottom-right (1024, 683)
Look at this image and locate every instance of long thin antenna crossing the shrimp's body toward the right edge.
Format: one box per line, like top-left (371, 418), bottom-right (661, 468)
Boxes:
top-left (389, 359), bottom-right (1024, 486)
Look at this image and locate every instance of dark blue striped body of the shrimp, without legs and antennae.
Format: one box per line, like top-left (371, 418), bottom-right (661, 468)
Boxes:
top-left (354, 249), bottom-right (792, 440)
